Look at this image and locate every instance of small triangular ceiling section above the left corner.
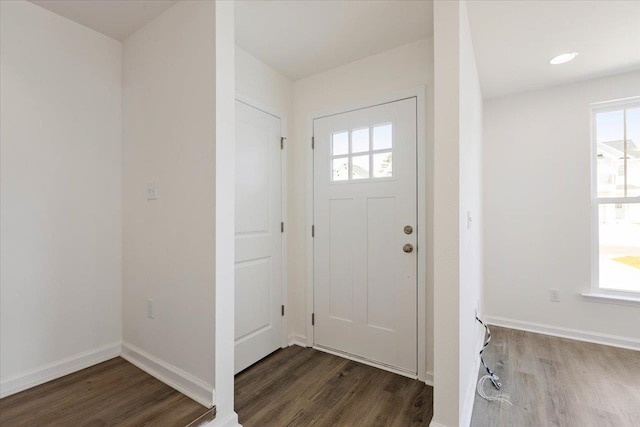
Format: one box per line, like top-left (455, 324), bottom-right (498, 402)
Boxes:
top-left (31, 0), bottom-right (177, 41)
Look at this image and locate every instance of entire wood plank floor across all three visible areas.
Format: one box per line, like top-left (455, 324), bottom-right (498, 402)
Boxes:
top-left (7, 327), bottom-right (640, 427)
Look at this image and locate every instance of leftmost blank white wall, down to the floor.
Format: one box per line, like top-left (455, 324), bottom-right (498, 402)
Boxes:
top-left (0, 1), bottom-right (122, 397)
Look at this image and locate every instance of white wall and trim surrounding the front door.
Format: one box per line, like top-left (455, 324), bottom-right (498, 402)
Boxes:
top-left (287, 40), bottom-right (433, 371)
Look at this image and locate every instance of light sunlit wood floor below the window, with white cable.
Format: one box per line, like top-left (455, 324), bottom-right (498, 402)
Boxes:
top-left (471, 326), bottom-right (640, 427)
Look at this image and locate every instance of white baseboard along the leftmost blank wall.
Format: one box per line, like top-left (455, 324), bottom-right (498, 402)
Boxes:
top-left (0, 342), bottom-right (120, 399)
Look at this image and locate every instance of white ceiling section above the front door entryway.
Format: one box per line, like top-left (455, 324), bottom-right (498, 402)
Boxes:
top-left (236, 0), bottom-right (433, 80)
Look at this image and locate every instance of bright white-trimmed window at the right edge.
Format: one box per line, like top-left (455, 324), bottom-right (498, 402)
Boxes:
top-left (591, 97), bottom-right (640, 292)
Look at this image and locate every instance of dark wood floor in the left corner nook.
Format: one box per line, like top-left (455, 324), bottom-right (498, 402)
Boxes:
top-left (0, 357), bottom-right (210, 427)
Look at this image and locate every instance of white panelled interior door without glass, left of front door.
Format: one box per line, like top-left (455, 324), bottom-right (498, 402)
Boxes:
top-left (235, 101), bottom-right (282, 373)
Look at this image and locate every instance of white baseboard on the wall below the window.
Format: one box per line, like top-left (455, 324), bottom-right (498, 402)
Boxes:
top-left (486, 316), bottom-right (640, 351)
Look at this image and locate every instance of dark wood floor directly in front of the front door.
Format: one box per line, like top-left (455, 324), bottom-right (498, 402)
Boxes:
top-left (235, 346), bottom-right (433, 427)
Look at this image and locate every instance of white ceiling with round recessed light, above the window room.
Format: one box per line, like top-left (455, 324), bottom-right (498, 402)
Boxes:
top-left (467, 0), bottom-right (640, 98)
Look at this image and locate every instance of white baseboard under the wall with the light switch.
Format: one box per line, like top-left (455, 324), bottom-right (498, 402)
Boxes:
top-left (121, 343), bottom-right (213, 408)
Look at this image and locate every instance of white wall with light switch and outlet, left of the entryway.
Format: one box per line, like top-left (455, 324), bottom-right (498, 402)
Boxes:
top-left (123, 1), bottom-right (218, 404)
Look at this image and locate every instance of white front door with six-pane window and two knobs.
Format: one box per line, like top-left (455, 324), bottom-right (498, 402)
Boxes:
top-left (313, 98), bottom-right (417, 375)
